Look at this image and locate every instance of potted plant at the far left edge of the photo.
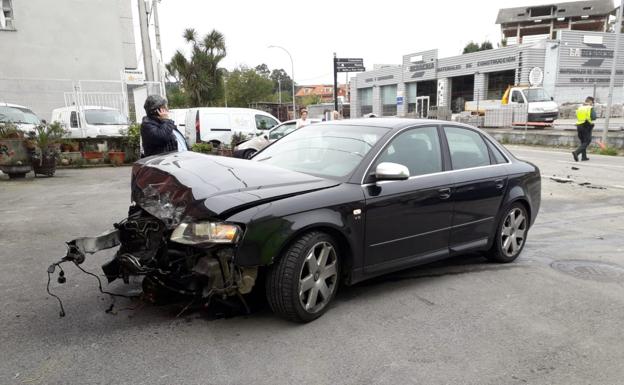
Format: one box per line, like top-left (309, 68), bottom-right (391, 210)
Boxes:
top-left (0, 122), bottom-right (31, 179)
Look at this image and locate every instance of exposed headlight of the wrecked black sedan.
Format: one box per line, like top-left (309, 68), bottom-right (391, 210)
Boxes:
top-left (171, 222), bottom-right (242, 245)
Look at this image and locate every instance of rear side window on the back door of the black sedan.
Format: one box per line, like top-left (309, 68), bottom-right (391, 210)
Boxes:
top-left (444, 127), bottom-right (490, 170)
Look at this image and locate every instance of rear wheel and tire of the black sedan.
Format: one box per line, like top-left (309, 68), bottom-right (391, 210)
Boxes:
top-left (485, 203), bottom-right (529, 263)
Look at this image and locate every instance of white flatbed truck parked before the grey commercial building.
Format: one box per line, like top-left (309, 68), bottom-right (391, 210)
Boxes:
top-left (465, 86), bottom-right (559, 125)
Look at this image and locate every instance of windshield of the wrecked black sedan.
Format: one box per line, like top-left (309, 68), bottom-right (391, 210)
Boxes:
top-left (252, 124), bottom-right (388, 178)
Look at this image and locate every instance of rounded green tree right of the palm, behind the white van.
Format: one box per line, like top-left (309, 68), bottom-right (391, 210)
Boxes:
top-left (227, 66), bottom-right (274, 107)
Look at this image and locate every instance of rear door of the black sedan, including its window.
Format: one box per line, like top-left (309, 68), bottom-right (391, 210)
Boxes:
top-left (443, 125), bottom-right (507, 253)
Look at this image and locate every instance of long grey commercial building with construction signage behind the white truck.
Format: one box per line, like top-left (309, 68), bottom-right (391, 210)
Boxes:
top-left (351, 0), bottom-right (624, 117)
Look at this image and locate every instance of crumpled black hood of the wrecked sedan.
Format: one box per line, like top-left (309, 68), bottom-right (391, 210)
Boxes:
top-left (132, 151), bottom-right (340, 224)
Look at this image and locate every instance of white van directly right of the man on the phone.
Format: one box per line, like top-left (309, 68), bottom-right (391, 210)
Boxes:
top-left (184, 107), bottom-right (280, 145)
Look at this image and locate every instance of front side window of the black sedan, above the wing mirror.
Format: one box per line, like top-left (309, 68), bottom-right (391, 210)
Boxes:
top-left (377, 126), bottom-right (442, 176)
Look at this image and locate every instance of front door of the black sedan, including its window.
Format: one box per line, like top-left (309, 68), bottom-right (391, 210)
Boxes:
top-left (363, 126), bottom-right (453, 274)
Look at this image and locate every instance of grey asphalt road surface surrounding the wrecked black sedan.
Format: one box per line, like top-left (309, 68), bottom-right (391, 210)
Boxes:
top-left (0, 146), bottom-right (624, 385)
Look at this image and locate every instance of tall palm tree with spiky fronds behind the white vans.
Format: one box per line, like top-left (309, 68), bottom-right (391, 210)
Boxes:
top-left (166, 28), bottom-right (226, 107)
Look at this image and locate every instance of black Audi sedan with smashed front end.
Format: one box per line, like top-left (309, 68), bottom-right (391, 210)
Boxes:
top-left (54, 118), bottom-right (541, 322)
